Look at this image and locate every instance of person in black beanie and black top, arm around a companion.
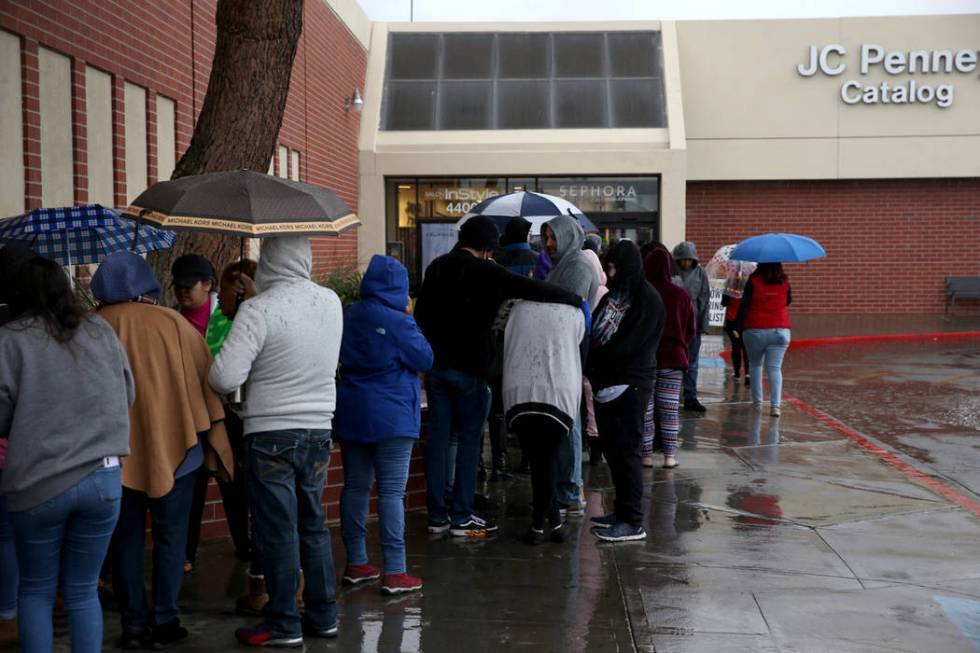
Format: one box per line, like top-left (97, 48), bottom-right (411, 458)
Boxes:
top-left (415, 216), bottom-right (583, 537)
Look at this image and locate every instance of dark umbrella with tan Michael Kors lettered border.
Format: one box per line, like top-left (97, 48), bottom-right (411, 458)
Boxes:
top-left (122, 170), bottom-right (360, 238)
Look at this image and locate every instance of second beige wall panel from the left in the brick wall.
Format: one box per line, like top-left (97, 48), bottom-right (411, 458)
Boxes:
top-left (38, 48), bottom-right (75, 206)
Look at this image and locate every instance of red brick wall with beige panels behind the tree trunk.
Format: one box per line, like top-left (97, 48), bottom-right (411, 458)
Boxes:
top-left (0, 0), bottom-right (367, 264)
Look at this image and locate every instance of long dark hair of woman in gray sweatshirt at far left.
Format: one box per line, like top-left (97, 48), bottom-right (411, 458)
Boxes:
top-left (0, 246), bottom-right (86, 342)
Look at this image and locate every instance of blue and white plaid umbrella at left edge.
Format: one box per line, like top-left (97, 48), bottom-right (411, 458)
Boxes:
top-left (0, 204), bottom-right (175, 265)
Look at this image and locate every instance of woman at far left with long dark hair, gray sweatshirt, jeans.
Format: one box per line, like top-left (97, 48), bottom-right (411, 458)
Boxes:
top-left (0, 246), bottom-right (134, 653)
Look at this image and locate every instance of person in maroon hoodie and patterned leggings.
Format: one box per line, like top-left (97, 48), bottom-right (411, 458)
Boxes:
top-left (643, 248), bottom-right (696, 469)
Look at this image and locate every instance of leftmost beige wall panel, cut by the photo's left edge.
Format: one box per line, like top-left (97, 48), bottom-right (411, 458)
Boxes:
top-left (0, 31), bottom-right (24, 218)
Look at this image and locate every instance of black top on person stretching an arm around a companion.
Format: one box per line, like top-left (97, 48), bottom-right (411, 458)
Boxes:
top-left (415, 249), bottom-right (582, 377)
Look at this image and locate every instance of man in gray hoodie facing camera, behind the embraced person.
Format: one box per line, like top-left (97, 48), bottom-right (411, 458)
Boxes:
top-left (541, 215), bottom-right (599, 516)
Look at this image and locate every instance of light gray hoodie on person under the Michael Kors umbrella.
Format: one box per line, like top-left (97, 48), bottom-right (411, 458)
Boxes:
top-left (208, 236), bottom-right (343, 435)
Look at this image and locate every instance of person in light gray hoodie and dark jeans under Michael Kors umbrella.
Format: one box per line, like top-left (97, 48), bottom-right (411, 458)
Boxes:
top-left (208, 236), bottom-right (343, 647)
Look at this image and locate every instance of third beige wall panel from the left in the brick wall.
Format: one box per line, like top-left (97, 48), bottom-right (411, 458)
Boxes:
top-left (85, 66), bottom-right (115, 206)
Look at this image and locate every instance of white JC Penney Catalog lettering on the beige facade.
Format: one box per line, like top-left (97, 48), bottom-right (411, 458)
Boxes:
top-left (796, 43), bottom-right (980, 109)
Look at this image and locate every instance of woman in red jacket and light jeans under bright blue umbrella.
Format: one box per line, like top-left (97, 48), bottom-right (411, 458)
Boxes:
top-left (735, 263), bottom-right (793, 417)
